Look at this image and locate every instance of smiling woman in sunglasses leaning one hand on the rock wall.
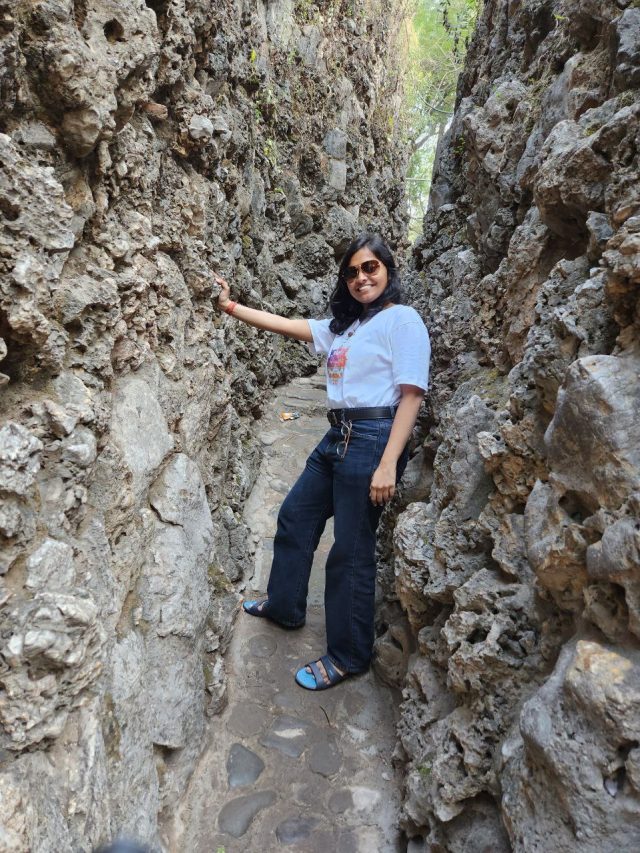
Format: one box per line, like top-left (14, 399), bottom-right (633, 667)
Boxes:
top-left (216, 234), bottom-right (430, 690)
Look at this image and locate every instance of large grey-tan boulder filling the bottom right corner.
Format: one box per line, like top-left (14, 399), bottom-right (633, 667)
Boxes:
top-left (503, 640), bottom-right (638, 851)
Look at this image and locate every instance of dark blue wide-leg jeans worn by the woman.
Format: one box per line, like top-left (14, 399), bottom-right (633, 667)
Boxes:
top-left (267, 419), bottom-right (407, 673)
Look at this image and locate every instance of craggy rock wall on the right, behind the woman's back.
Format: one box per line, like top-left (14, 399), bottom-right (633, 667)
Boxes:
top-left (390, 0), bottom-right (640, 853)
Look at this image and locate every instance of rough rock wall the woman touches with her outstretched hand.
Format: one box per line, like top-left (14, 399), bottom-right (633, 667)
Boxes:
top-left (0, 0), bottom-right (405, 853)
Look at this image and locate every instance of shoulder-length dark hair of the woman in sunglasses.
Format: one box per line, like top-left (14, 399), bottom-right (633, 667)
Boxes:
top-left (329, 234), bottom-right (403, 335)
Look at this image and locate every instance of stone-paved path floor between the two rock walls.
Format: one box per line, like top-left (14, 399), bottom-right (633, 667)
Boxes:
top-left (170, 377), bottom-right (404, 853)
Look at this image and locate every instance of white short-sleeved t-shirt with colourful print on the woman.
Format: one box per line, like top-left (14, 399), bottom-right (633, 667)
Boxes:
top-left (309, 305), bottom-right (431, 409)
